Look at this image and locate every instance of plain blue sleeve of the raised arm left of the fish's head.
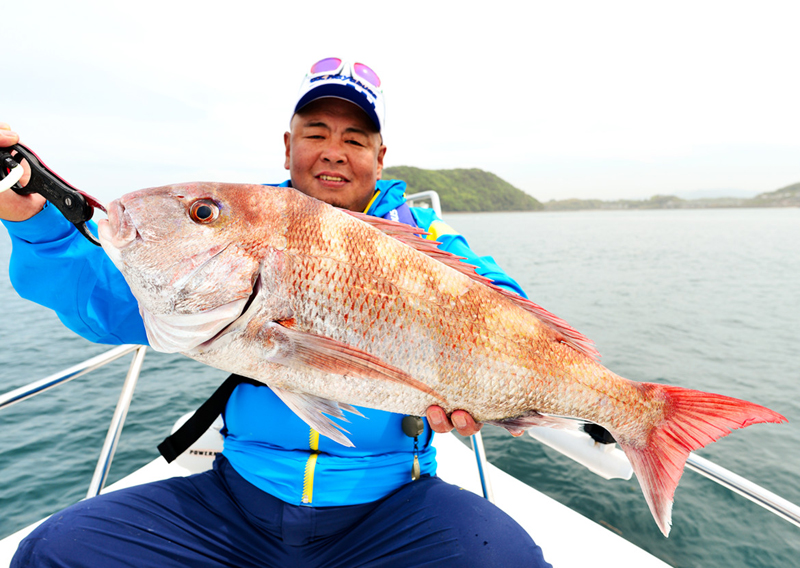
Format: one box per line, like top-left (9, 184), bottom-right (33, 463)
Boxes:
top-left (3, 206), bottom-right (147, 345)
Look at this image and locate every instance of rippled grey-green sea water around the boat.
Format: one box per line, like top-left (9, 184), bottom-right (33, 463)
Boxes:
top-left (0, 209), bottom-right (800, 568)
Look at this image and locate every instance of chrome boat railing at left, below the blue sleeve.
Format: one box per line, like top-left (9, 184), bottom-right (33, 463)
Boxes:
top-left (0, 345), bottom-right (147, 497)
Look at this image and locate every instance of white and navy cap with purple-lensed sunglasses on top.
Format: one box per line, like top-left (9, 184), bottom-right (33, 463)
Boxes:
top-left (294, 57), bottom-right (386, 135)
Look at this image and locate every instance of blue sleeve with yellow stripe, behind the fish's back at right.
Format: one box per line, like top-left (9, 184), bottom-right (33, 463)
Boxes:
top-left (411, 207), bottom-right (528, 298)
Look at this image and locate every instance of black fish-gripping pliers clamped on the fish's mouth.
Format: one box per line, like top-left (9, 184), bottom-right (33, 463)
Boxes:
top-left (0, 144), bottom-right (105, 246)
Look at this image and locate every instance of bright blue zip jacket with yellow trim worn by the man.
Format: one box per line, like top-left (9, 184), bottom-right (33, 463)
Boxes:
top-left (4, 181), bottom-right (524, 507)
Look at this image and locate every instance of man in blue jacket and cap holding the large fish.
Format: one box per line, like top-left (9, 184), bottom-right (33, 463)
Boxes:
top-left (0, 59), bottom-right (547, 566)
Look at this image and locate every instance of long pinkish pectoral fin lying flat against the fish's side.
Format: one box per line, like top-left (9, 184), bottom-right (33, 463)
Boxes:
top-left (259, 322), bottom-right (444, 400)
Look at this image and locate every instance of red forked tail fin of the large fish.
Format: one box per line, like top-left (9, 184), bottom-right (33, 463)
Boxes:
top-left (611, 383), bottom-right (786, 536)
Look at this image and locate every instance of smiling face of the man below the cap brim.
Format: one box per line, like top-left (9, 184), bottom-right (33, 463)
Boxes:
top-left (283, 98), bottom-right (386, 211)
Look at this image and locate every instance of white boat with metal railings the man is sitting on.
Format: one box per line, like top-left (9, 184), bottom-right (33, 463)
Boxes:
top-left (0, 194), bottom-right (800, 568)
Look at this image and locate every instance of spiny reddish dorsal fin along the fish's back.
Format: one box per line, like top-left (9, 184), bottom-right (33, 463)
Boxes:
top-left (342, 209), bottom-right (600, 361)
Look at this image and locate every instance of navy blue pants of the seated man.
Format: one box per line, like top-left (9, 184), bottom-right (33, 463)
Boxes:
top-left (11, 456), bottom-right (550, 568)
